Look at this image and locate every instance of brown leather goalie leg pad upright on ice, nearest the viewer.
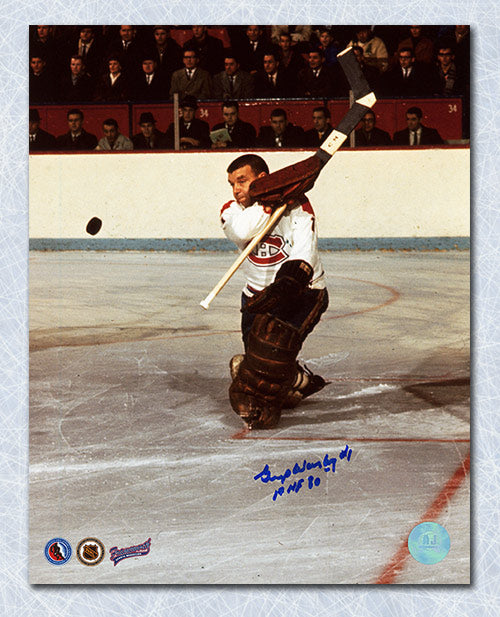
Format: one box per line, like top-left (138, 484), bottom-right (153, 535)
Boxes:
top-left (229, 314), bottom-right (301, 429)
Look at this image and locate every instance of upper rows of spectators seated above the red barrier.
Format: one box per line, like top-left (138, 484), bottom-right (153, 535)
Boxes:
top-left (30, 26), bottom-right (469, 104)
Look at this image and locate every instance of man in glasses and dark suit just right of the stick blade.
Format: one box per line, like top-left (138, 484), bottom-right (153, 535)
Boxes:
top-left (381, 47), bottom-right (433, 97)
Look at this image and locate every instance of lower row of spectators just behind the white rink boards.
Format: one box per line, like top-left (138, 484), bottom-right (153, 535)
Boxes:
top-left (29, 95), bottom-right (444, 152)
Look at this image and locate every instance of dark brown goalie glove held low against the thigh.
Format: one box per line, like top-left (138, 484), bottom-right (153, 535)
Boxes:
top-left (245, 259), bottom-right (313, 314)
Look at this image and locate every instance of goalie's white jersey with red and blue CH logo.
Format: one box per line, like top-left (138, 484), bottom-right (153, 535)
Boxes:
top-left (220, 198), bottom-right (325, 296)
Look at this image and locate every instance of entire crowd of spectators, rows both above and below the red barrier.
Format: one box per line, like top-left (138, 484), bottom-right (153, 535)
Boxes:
top-left (29, 26), bottom-right (470, 150)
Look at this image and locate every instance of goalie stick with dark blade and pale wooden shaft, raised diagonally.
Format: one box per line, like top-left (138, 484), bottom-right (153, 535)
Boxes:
top-left (200, 47), bottom-right (377, 310)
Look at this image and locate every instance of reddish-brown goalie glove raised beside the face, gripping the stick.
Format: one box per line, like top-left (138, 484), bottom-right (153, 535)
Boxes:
top-left (249, 155), bottom-right (324, 208)
